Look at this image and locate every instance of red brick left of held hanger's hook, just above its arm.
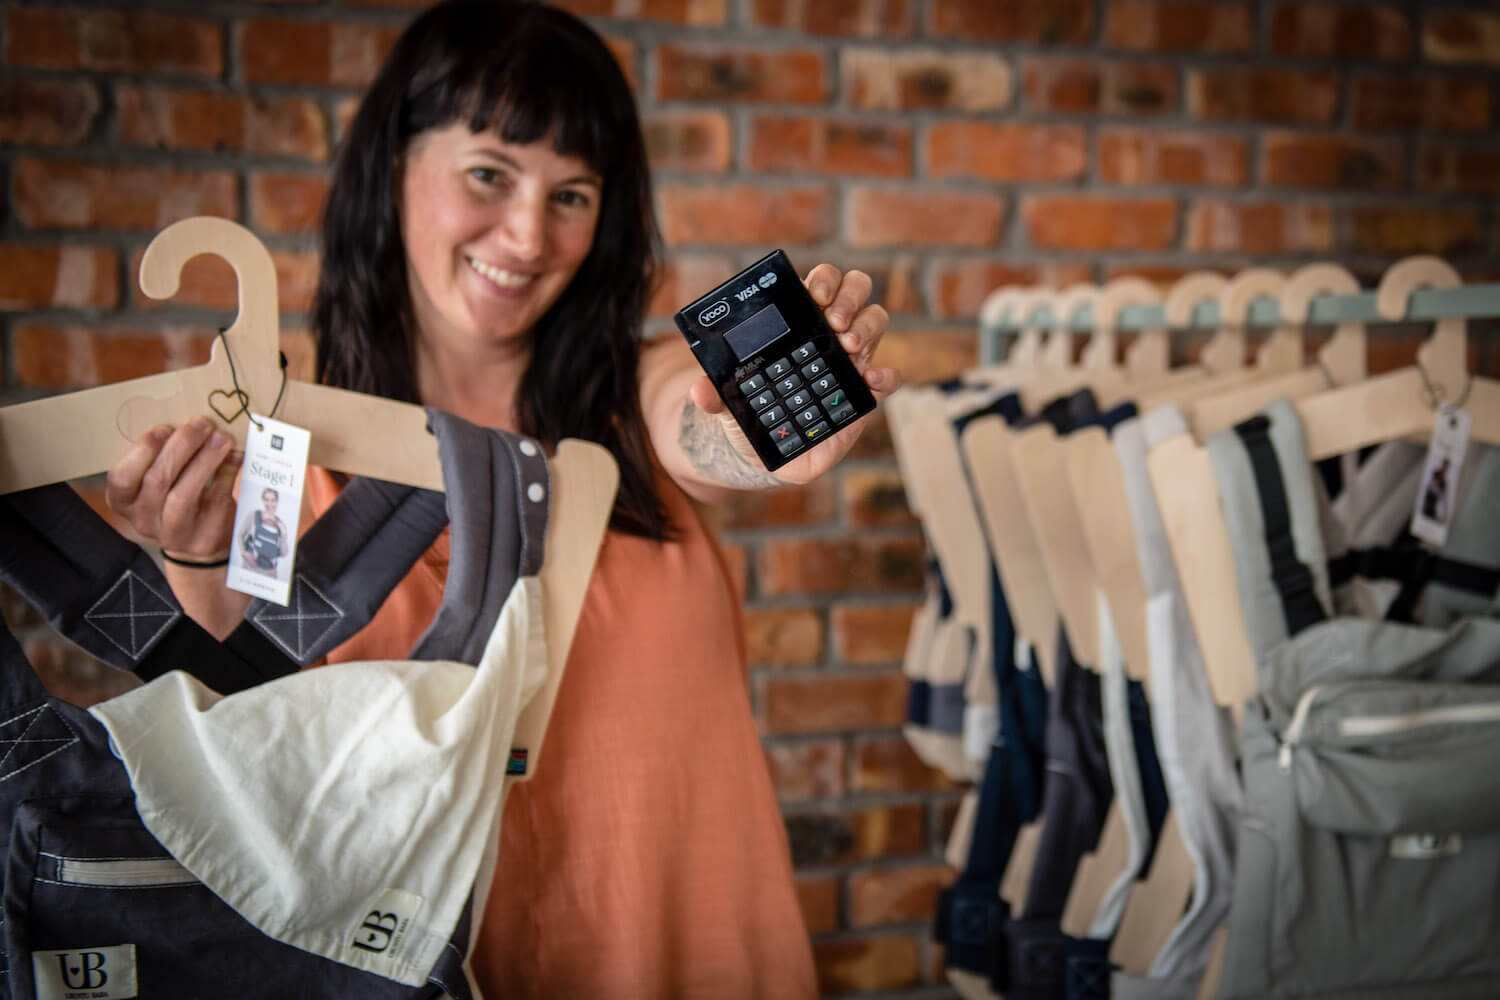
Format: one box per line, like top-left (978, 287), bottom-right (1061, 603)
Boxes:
top-left (11, 324), bottom-right (213, 388)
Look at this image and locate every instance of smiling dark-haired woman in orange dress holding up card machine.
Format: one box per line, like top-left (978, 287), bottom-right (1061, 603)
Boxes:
top-left (108, 0), bottom-right (899, 997)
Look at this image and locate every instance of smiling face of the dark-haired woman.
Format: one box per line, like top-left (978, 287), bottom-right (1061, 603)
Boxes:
top-left (401, 121), bottom-right (602, 358)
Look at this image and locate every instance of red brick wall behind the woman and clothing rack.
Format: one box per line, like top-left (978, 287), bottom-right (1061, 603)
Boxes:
top-left (0, 0), bottom-right (1500, 996)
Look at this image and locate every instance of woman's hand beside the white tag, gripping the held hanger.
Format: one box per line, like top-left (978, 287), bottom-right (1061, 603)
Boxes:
top-left (104, 417), bottom-right (242, 561)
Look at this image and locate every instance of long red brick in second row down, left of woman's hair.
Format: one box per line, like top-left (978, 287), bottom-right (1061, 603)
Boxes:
top-left (116, 85), bottom-right (329, 160)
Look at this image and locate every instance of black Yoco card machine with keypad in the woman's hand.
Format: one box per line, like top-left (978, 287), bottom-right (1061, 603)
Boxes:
top-left (672, 250), bottom-right (875, 469)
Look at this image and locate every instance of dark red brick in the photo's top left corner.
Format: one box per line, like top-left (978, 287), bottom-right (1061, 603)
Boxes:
top-left (5, 7), bottom-right (224, 76)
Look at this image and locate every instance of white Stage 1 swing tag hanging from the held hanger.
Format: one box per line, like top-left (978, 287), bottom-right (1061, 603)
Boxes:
top-left (225, 415), bottom-right (312, 607)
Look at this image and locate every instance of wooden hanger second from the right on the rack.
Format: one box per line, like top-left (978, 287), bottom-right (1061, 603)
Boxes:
top-left (1193, 264), bottom-right (1368, 441)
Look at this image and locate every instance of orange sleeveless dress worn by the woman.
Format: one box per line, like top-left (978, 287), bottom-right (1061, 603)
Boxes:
top-left (308, 469), bottom-right (818, 1000)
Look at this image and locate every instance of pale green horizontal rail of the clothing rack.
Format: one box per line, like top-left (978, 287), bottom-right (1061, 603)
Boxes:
top-left (980, 283), bottom-right (1500, 364)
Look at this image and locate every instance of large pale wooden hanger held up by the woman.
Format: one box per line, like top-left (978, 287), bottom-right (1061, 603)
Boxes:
top-left (0, 216), bottom-right (620, 781)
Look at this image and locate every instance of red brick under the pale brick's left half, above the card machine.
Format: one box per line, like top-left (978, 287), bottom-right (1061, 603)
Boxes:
top-left (750, 115), bottom-right (912, 177)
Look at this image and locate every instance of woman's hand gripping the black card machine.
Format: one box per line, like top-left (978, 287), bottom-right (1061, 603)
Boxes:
top-left (692, 264), bottom-right (902, 483)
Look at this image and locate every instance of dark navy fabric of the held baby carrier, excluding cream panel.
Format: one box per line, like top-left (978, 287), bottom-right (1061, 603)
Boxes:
top-left (0, 411), bottom-right (549, 1000)
